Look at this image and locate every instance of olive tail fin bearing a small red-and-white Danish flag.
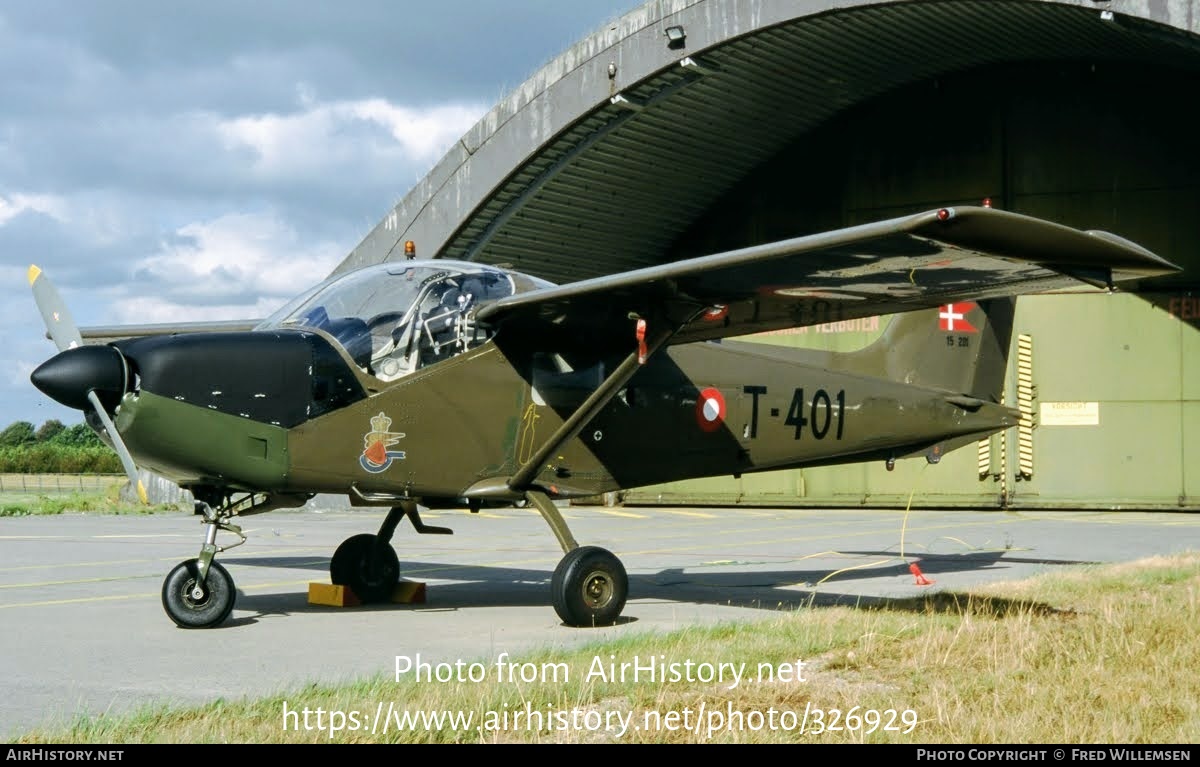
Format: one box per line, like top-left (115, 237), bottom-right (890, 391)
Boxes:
top-left (838, 298), bottom-right (1016, 402)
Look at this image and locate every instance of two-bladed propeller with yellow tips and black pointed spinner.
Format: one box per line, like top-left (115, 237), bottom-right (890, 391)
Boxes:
top-left (29, 265), bottom-right (150, 503)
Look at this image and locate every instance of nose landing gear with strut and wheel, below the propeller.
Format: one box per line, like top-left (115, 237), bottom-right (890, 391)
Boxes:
top-left (162, 501), bottom-right (246, 629)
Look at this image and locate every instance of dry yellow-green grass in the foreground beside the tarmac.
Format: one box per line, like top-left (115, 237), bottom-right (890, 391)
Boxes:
top-left (11, 553), bottom-right (1200, 744)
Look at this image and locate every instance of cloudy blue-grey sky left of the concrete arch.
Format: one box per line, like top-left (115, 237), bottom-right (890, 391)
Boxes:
top-left (0, 0), bottom-right (640, 429)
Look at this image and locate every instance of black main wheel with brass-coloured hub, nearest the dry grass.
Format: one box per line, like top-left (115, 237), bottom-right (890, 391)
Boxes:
top-left (550, 546), bottom-right (629, 627)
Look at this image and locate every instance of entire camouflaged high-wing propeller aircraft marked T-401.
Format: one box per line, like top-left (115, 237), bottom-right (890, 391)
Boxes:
top-left (29, 206), bottom-right (1177, 628)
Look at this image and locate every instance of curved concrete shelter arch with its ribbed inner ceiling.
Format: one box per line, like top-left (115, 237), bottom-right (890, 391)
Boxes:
top-left (335, 0), bottom-right (1200, 281)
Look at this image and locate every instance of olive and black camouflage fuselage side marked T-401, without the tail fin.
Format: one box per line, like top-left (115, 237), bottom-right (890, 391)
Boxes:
top-left (116, 342), bottom-right (1016, 499)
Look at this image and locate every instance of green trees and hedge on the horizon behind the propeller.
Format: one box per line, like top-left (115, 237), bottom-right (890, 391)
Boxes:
top-left (0, 419), bottom-right (122, 474)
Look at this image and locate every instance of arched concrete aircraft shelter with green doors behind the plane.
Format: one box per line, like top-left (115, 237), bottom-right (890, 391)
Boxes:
top-left (336, 0), bottom-right (1200, 508)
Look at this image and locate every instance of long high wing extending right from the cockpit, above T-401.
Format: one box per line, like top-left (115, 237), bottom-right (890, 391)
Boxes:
top-left (479, 206), bottom-right (1180, 350)
